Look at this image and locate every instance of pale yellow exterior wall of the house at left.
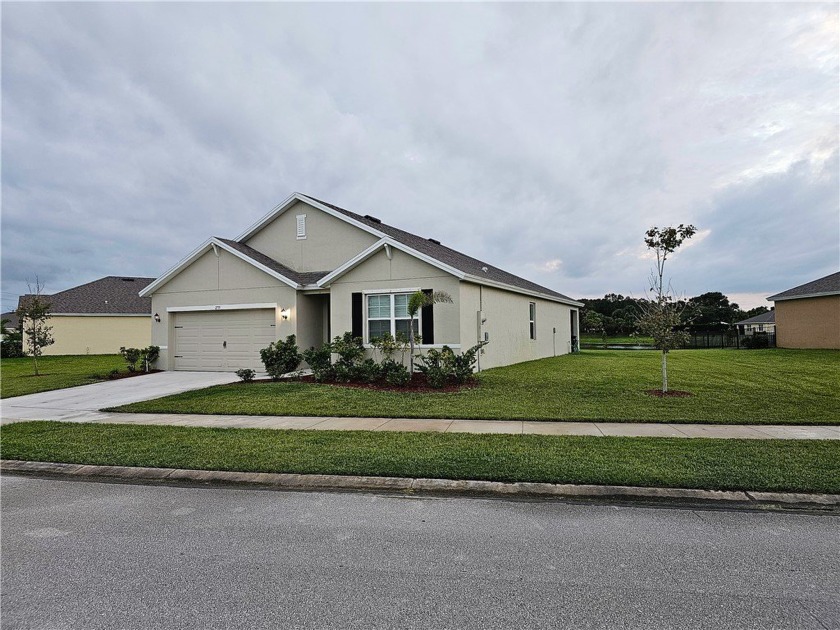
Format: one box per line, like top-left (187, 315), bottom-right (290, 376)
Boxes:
top-left (32, 315), bottom-right (152, 356)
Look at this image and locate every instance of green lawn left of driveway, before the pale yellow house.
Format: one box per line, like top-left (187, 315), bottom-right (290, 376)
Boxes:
top-left (0, 354), bottom-right (125, 398)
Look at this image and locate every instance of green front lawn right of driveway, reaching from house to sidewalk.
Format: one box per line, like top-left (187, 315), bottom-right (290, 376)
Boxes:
top-left (117, 349), bottom-right (840, 424)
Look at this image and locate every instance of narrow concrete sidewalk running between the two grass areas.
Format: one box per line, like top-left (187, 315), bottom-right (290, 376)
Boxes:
top-left (0, 407), bottom-right (840, 440)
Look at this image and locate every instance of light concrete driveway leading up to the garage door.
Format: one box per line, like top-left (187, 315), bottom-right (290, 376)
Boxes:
top-left (0, 372), bottom-right (239, 422)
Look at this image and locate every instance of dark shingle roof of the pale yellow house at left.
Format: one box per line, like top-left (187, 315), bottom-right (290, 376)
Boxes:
top-left (19, 276), bottom-right (154, 315)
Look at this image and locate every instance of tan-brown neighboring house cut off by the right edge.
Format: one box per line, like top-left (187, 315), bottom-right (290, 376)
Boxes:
top-left (767, 272), bottom-right (840, 350)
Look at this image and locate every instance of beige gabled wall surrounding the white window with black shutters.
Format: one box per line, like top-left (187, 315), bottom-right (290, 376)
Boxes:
top-left (330, 248), bottom-right (461, 356)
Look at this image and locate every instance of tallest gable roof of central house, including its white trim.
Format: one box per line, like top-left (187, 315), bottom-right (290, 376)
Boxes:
top-left (236, 193), bottom-right (583, 306)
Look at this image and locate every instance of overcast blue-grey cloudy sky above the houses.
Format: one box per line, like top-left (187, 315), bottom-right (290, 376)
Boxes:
top-left (2, 3), bottom-right (840, 310)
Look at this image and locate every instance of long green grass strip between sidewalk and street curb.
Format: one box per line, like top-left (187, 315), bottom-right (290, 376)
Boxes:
top-left (2, 422), bottom-right (840, 493)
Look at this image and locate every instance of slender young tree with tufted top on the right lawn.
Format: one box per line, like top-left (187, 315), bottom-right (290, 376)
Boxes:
top-left (639, 223), bottom-right (697, 393)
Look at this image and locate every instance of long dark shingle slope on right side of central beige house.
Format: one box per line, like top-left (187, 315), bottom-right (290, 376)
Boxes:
top-left (296, 195), bottom-right (574, 301)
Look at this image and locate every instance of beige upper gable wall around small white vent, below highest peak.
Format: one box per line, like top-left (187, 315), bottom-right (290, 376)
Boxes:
top-left (241, 202), bottom-right (378, 271)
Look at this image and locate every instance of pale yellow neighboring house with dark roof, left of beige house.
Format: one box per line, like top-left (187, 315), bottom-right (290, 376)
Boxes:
top-left (20, 276), bottom-right (154, 355)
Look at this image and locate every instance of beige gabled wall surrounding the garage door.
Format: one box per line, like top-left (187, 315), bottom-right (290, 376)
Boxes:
top-left (151, 249), bottom-right (299, 370)
